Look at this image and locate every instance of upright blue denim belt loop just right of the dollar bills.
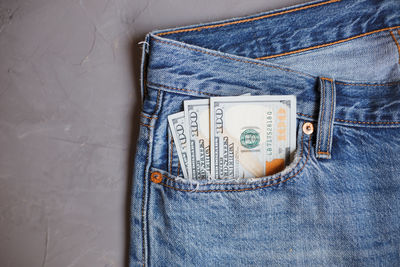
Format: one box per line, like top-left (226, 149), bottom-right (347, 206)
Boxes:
top-left (315, 77), bottom-right (336, 159)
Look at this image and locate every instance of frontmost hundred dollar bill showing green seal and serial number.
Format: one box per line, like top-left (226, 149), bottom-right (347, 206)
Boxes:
top-left (210, 95), bottom-right (296, 179)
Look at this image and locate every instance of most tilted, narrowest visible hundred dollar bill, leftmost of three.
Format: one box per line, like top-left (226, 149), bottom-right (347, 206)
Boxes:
top-left (168, 111), bottom-right (190, 179)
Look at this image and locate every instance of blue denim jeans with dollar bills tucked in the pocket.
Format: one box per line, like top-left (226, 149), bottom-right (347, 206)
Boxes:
top-left (129, 0), bottom-right (400, 266)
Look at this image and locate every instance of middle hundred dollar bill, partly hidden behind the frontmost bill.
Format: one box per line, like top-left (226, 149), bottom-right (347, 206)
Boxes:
top-left (183, 99), bottom-right (211, 180)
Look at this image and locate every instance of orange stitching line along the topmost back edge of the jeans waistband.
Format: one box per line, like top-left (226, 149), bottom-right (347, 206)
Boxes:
top-left (156, 0), bottom-right (341, 36)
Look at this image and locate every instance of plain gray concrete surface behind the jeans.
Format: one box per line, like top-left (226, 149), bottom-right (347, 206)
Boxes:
top-left (0, 0), bottom-right (306, 267)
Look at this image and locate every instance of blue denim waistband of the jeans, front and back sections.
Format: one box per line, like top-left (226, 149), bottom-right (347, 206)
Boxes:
top-left (143, 0), bottom-right (400, 127)
